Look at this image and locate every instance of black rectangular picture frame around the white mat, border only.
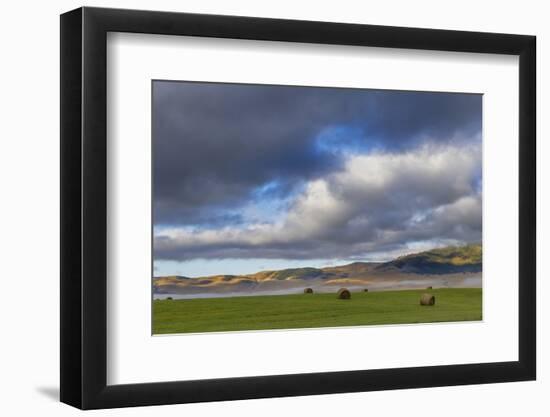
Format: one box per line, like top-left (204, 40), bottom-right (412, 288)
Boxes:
top-left (60, 7), bottom-right (536, 409)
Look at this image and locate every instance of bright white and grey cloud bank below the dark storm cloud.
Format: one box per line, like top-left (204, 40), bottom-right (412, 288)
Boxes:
top-left (155, 143), bottom-right (481, 259)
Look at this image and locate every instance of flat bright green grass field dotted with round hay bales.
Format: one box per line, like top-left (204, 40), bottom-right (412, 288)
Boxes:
top-left (153, 288), bottom-right (482, 334)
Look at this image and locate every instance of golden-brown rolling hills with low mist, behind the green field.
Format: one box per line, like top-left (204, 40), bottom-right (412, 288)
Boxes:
top-left (153, 240), bottom-right (482, 296)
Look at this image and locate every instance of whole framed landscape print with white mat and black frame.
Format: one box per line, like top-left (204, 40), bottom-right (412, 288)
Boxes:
top-left (61, 8), bottom-right (536, 409)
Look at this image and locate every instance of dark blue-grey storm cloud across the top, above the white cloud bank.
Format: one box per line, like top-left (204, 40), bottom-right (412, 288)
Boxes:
top-left (153, 81), bottom-right (481, 228)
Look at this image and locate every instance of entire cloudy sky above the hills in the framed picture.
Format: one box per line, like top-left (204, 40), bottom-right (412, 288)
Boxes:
top-left (152, 81), bottom-right (482, 277)
